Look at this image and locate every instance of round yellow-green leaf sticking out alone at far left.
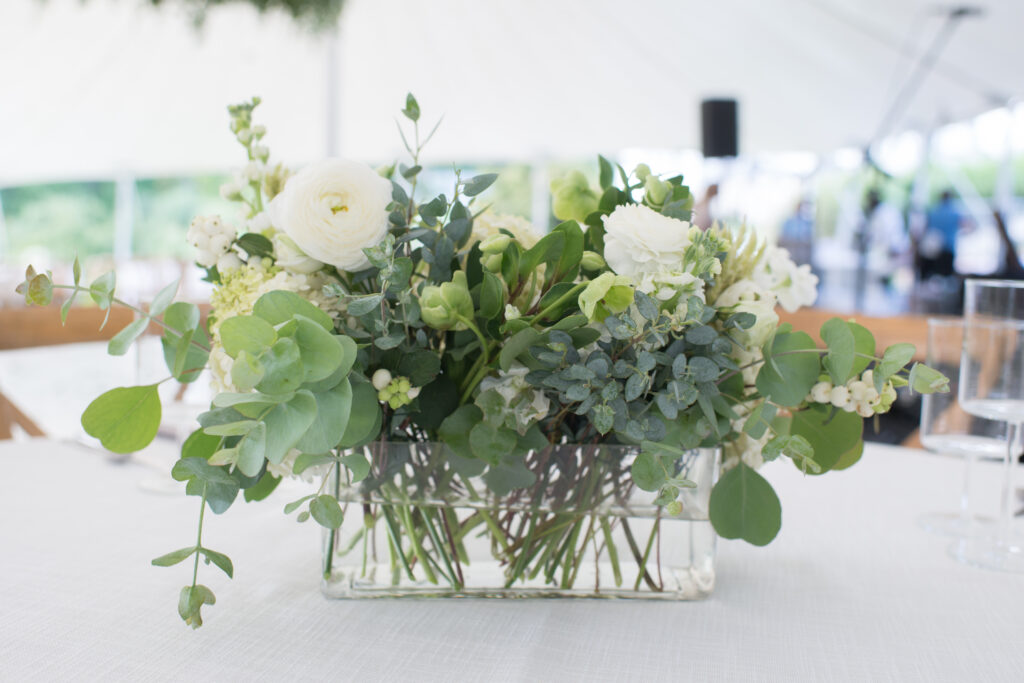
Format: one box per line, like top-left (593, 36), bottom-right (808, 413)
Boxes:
top-left (82, 384), bottom-right (161, 453)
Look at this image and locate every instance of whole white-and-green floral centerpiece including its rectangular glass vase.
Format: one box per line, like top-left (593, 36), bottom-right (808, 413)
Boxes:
top-left (20, 95), bottom-right (945, 627)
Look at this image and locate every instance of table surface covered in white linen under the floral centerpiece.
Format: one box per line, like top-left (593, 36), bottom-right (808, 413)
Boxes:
top-left (0, 440), bottom-right (1024, 681)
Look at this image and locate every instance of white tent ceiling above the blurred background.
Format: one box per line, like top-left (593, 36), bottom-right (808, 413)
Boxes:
top-left (0, 0), bottom-right (1024, 185)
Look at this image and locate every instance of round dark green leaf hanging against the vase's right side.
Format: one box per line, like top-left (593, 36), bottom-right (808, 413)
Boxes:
top-left (710, 463), bottom-right (782, 546)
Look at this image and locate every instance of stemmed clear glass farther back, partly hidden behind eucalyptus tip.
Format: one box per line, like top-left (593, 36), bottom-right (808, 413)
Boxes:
top-left (918, 317), bottom-right (1007, 538)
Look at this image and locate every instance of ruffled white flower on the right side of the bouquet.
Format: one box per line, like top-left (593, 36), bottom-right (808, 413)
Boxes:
top-left (604, 204), bottom-right (690, 281)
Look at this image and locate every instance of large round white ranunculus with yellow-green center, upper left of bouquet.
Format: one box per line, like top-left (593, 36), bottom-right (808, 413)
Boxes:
top-left (269, 159), bottom-right (391, 271)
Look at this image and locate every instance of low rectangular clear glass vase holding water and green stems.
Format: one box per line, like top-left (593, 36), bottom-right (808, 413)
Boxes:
top-left (323, 442), bottom-right (720, 600)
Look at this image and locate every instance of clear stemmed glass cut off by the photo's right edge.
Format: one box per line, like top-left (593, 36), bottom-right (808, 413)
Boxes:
top-left (952, 280), bottom-right (1024, 573)
